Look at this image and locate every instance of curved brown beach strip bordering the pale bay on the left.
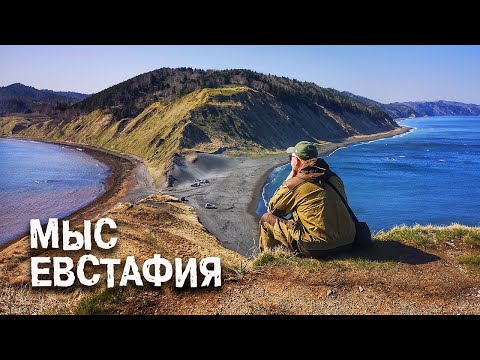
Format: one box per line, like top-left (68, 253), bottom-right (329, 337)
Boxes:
top-left (0, 136), bottom-right (158, 251)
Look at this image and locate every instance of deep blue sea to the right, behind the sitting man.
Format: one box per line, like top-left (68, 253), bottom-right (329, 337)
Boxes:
top-left (257, 116), bottom-right (480, 231)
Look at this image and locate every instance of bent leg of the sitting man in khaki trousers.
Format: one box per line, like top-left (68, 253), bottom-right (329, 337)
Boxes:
top-left (258, 213), bottom-right (291, 251)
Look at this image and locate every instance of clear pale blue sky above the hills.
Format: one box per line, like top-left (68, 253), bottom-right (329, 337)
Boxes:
top-left (0, 45), bottom-right (480, 104)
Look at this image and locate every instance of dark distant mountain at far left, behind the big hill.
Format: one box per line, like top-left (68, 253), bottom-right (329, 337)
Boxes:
top-left (0, 83), bottom-right (89, 115)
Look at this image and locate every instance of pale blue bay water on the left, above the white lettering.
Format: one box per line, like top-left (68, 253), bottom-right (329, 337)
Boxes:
top-left (0, 139), bottom-right (110, 244)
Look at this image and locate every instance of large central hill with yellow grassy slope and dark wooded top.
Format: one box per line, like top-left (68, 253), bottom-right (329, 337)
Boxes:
top-left (0, 68), bottom-right (398, 186)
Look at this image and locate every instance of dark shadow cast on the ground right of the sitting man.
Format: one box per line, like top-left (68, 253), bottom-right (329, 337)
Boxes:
top-left (342, 240), bottom-right (440, 265)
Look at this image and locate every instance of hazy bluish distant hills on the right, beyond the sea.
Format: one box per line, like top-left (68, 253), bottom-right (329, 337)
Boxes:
top-left (342, 91), bottom-right (480, 119)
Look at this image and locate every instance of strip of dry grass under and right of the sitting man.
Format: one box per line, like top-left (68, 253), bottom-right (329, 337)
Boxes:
top-left (253, 224), bottom-right (480, 273)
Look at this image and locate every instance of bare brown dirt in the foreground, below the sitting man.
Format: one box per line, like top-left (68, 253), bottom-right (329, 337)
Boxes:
top-left (113, 239), bottom-right (480, 315)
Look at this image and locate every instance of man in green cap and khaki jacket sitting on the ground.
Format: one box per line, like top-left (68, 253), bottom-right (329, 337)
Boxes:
top-left (259, 141), bottom-right (355, 257)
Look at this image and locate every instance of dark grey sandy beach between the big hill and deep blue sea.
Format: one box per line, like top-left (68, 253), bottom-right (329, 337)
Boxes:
top-left (165, 127), bottom-right (411, 257)
